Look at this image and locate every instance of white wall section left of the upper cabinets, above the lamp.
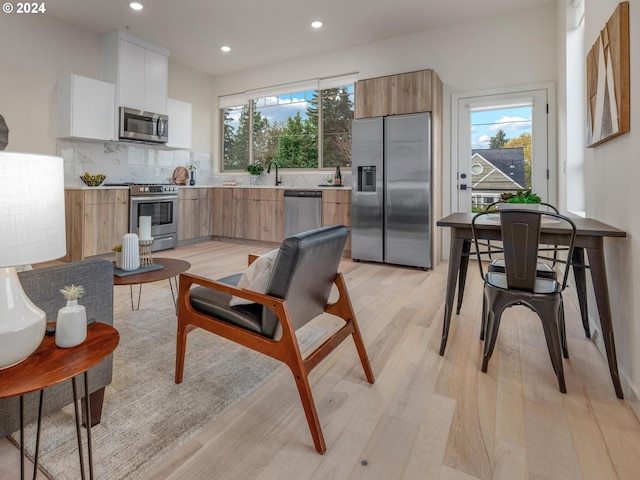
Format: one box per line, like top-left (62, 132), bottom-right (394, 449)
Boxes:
top-left (0, 15), bottom-right (101, 154)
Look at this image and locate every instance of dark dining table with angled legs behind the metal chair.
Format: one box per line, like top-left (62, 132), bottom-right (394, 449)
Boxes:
top-left (437, 213), bottom-right (627, 398)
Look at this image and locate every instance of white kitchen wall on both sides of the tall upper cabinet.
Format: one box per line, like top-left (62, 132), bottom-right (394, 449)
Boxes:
top-left (0, 15), bottom-right (217, 154)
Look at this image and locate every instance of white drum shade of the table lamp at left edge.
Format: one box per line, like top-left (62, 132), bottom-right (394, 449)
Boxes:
top-left (0, 152), bottom-right (67, 267)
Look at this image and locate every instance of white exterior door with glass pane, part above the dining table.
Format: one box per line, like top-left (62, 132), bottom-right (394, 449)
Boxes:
top-left (452, 85), bottom-right (555, 212)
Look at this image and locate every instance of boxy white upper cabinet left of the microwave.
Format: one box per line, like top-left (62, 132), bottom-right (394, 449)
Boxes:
top-left (57, 74), bottom-right (115, 140)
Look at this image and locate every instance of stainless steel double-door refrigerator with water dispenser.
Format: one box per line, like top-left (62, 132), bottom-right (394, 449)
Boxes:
top-left (351, 113), bottom-right (432, 269)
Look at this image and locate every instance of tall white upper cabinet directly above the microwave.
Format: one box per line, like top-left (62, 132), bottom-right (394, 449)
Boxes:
top-left (102, 30), bottom-right (169, 114)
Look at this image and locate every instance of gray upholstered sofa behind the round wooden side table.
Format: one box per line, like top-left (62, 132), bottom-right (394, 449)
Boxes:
top-left (0, 259), bottom-right (113, 437)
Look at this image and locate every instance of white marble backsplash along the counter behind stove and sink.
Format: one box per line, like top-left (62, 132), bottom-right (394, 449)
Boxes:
top-left (57, 139), bottom-right (351, 187)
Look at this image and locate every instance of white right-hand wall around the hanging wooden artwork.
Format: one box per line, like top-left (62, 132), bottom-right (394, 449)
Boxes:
top-left (585, 0), bottom-right (640, 416)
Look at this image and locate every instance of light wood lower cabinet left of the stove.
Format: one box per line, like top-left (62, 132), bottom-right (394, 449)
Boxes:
top-left (64, 188), bottom-right (129, 261)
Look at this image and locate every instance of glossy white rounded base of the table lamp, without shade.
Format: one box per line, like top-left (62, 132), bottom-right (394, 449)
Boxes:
top-left (0, 267), bottom-right (47, 370)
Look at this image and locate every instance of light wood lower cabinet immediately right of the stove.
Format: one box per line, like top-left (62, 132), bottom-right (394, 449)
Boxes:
top-left (178, 187), bottom-right (215, 242)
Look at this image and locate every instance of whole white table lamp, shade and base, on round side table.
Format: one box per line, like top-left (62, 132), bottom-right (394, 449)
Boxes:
top-left (0, 151), bottom-right (66, 369)
